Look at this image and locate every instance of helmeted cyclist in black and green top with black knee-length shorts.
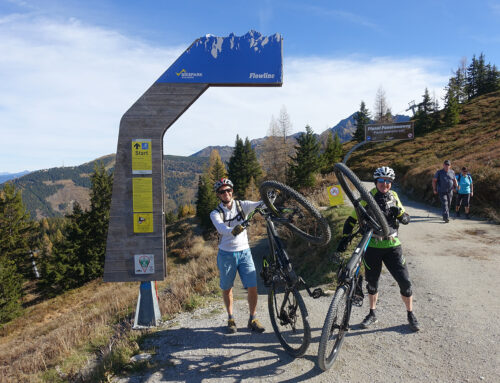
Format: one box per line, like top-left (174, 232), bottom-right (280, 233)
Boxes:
top-left (337, 166), bottom-right (420, 331)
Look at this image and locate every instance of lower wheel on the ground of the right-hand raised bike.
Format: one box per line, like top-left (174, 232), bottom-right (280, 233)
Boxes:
top-left (318, 285), bottom-right (350, 371)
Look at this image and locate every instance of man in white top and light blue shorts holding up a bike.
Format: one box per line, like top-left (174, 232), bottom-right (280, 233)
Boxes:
top-left (210, 178), bottom-right (264, 333)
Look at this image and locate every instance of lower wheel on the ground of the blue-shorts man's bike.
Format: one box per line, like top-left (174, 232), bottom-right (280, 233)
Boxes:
top-left (268, 283), bottom-right (311, 357)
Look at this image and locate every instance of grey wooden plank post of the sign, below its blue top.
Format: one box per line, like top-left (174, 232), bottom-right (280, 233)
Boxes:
top-left (104, 84), bottom-right (208, 282)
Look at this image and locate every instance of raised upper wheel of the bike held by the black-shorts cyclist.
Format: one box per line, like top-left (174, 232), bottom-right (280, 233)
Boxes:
top-left (333, 162), bottom-right (389, 236)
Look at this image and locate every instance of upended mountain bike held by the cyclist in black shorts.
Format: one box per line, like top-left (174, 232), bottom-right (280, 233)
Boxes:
top-left (318, 163), bottom-right (389, 371)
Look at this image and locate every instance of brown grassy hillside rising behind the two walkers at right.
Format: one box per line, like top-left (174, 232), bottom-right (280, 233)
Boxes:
top-left (345, 91), bottom-right (500, 222)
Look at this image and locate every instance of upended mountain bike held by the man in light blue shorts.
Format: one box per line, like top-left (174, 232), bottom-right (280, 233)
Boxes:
top-left (242, 181), bottom-right (331, 357)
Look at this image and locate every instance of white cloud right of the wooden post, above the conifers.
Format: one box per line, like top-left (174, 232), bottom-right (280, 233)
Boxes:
top-left (164, 58), bottom-right (449, 154)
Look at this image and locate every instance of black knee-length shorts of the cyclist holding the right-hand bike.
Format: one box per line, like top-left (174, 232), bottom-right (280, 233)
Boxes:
top-left (364, 246), bottom-right (412, 297)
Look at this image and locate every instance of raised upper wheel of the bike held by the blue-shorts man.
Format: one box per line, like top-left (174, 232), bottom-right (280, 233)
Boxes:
top-left (259, 181), bottom-right (332, 245)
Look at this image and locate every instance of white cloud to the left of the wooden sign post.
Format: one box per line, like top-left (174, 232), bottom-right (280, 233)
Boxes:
top-left (0, 16), bottom-right (182, 171)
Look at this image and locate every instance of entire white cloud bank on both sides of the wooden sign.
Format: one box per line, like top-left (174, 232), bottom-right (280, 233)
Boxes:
top-left (0, 15), bottom-right (449, 172)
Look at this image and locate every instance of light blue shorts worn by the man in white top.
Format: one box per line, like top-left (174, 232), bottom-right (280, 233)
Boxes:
top-left (217, 249), bottom-right (257, 290)
